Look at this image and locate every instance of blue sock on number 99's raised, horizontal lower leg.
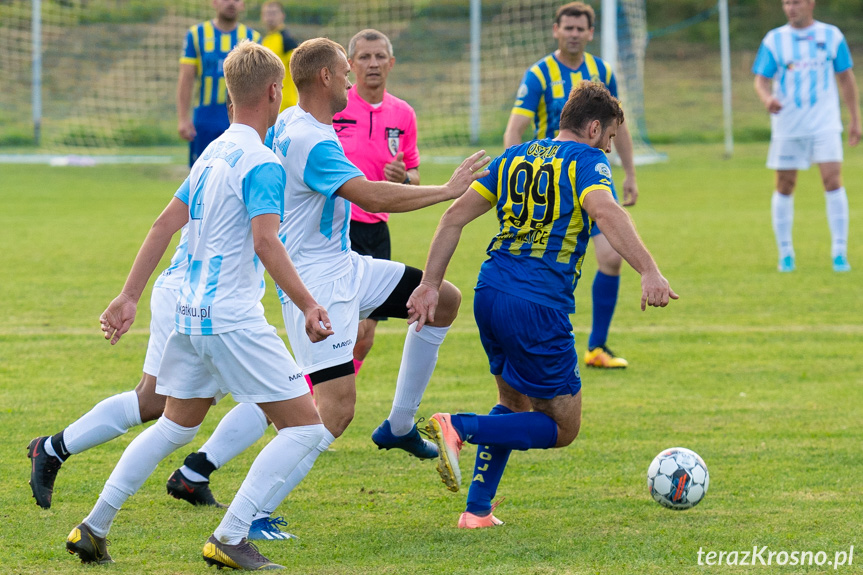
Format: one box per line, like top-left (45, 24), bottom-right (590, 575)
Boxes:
top-left (450, 411), bottom-right (557, 451)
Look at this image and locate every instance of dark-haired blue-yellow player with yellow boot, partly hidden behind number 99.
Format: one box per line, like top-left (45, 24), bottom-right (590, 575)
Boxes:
top-left (503, 2), bottom-right (638, 368)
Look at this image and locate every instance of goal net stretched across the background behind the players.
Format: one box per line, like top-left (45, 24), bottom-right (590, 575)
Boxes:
top-left (0, 0), bottom-right (651, 155)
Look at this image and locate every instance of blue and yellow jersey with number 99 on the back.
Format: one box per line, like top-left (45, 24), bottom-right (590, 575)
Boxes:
top-left (471, 138), bottom-right (613, 313)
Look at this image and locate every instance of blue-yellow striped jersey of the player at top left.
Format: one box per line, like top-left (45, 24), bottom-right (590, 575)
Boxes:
top-left (180, 20), bottom-right (261, 127)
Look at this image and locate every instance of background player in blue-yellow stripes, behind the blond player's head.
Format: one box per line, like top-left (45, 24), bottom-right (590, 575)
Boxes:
top-left (177, 0), bottom-right (261, 166)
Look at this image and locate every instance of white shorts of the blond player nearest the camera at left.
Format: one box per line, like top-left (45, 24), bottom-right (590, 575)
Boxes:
top-left (156, 325), bottom-right (309, 403)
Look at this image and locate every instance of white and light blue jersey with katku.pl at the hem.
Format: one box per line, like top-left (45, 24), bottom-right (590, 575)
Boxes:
top-left (175, 124), bottom-right (285, 335)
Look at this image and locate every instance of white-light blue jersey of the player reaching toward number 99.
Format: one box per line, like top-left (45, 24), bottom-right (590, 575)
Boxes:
top-left (268, 106), bottom-right (363, 303)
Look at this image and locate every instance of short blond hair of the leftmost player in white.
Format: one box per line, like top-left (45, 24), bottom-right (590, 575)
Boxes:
top-left (224, 40), bottom-right (285, 106)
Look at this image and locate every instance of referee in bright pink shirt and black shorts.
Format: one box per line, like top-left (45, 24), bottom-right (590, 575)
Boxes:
top-left (333, 29), bottom-right (420, 373)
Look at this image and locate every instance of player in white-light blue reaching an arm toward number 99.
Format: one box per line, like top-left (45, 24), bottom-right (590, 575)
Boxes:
top-left (167, 38), bottom-right (489, 536)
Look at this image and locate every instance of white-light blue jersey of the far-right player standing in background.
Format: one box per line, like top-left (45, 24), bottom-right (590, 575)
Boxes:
top-left (752, 21), bottom-right (854, 138)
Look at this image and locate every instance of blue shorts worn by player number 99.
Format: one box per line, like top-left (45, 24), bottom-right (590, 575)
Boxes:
top-left (473, 287), bottom-right (581, 399)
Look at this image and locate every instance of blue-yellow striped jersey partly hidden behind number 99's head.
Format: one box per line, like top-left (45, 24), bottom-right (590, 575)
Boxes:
top-left (512, 52), bottom-right (617, 142)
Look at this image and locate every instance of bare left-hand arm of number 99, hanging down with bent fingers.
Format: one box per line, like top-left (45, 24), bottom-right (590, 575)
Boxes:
top-left (407, 191), bottom-right (491, 331)
